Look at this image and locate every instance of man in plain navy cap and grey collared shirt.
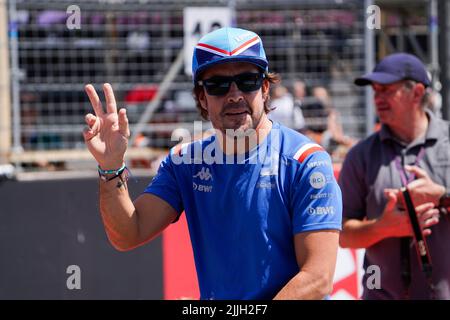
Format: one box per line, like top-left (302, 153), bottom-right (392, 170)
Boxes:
top-left (339, 53), bottom-right (450, 299)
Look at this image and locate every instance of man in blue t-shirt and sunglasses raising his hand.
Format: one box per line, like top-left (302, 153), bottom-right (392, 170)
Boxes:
top-left (84, 28), bottom-right (342, 299)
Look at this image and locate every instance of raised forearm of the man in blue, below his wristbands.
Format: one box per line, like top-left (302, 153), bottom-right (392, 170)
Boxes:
top-left (99, 177), bottom-right (139, 251)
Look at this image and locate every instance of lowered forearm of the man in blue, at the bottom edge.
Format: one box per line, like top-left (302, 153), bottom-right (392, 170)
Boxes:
top-left (274, 271), bottom-right (333, 300)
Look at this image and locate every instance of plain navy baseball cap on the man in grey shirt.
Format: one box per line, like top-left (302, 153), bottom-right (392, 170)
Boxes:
top-left (355, 53), bottom-right (431, 87)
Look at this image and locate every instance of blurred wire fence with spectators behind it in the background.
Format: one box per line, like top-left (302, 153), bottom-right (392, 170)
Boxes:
top-left (0, 0), bottom-right (442, 176)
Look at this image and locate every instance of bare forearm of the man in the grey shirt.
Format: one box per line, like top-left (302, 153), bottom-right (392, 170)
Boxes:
top-left (339, 219), bottom-right (385, 248)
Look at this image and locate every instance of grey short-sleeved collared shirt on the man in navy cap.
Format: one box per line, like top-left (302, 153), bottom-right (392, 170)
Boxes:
top-left (339, 111), bottom-right (450, 299)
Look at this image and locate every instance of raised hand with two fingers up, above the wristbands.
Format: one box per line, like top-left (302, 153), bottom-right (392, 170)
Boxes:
top-left (83, 83), bottom-right (130, 170)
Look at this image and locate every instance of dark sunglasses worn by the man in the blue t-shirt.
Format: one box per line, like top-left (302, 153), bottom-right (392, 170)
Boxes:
top-left (197, 72), bottom-right (265, 96)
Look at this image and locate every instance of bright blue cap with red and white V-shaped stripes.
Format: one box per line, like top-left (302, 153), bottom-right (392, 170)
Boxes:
top-left (192, 27), bottom-right (269, 83)
